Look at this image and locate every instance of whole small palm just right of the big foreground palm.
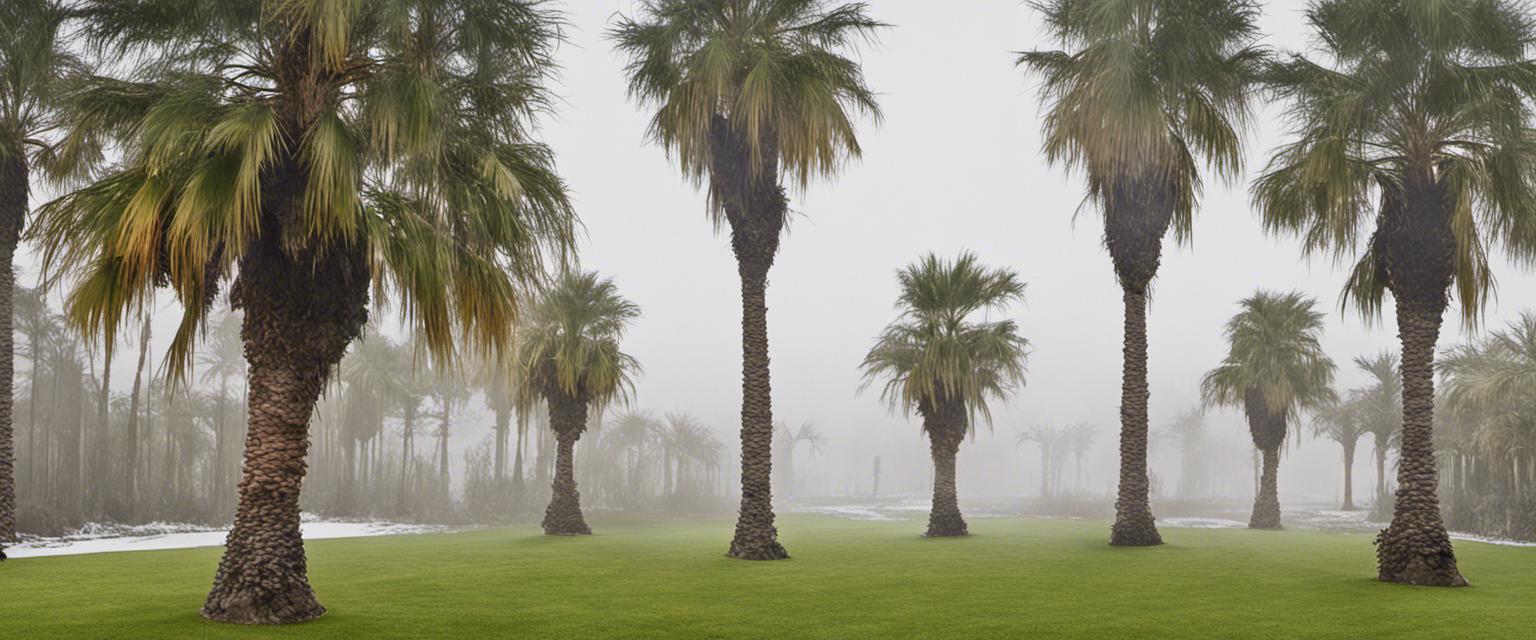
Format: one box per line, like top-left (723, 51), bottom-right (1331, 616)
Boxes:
top-left (518, 272), bottom-right (641, 536)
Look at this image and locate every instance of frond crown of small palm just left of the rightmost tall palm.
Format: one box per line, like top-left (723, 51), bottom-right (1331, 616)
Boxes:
top-left (1200, 292), bottom-right (1336, 416)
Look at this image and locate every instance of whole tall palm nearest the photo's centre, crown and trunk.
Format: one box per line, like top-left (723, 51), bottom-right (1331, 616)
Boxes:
top-left (610, 0), bottom-right (883, 560)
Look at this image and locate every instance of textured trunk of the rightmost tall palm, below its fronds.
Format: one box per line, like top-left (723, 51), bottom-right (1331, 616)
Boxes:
top-left (1376, 302), bottom-right (1467, 586)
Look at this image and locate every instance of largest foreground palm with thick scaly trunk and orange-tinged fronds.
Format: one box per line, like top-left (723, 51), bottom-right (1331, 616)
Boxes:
top-left (32, 0), bottom-right (574, 623)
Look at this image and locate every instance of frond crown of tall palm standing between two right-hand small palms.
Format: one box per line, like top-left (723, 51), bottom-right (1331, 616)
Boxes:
top-left (1018, 0), bottom-right (1267, 241)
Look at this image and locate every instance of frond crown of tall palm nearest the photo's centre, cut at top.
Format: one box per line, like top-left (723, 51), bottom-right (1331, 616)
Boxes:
top-left (610, 0), bottom-right (885, 215)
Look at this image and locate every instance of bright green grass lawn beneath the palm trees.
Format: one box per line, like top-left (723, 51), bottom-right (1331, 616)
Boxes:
top-left (0, 516), bottom-right (1536, 640)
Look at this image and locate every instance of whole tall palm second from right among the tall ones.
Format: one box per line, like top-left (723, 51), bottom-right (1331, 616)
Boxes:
top-left (1018, 0), bottom-right (1264, 546)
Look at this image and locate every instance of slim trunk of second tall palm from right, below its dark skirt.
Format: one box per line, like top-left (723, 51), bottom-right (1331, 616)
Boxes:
top-left (1109, 287), bottom-right (1163, 546)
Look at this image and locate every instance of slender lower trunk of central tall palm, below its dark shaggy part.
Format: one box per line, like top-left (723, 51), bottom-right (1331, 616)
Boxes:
top-left (727, 231), bottom-right (790, 560)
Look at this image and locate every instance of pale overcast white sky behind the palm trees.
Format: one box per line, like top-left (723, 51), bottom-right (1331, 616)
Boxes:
top-left (23, 0), bottom-right (1536, 499)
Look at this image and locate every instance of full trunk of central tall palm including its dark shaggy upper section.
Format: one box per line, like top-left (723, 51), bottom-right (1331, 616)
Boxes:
top-left (710, 117), bottom-right (790, 560)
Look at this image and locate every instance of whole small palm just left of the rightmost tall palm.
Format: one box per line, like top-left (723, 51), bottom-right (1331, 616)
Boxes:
top-left (1200, 292), bottom-right (1335, 529)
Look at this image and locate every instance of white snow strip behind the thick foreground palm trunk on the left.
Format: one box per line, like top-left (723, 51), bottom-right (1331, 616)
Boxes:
top-left (5, 514), bottom-right (449, 559)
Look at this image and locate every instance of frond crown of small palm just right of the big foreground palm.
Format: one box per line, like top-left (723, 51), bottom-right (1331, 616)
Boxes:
top-left (518, 272), bottom-right (641, 411)
